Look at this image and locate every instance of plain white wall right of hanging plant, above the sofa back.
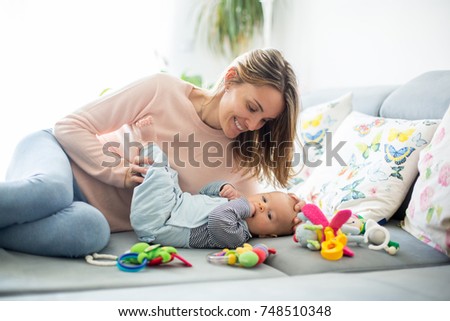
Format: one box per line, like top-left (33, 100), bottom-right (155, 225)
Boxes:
top-left (273, 0), bottom-right (450, 91)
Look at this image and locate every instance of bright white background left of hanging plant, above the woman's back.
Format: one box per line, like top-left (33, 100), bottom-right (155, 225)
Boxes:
top-left (0, 0), bottom-right (174, 180)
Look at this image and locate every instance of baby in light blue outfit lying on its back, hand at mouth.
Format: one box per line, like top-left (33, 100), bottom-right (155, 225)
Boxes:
top-left (130, 117), bottom-right (299, 248)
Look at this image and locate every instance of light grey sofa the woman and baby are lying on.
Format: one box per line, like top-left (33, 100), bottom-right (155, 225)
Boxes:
top-left (0, 70), bottom-right (450, 301)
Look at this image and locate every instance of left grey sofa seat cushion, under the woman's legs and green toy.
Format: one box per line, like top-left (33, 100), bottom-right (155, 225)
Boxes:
top-left (0, 232), bottom-right (285, 299)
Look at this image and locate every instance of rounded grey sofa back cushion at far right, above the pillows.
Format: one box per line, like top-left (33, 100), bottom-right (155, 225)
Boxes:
top-left (380, 70), bottom-right (450, 119)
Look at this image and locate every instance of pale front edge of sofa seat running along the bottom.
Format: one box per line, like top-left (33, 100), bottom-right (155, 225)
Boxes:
top-left (7, 265), bottom-right (450, 298)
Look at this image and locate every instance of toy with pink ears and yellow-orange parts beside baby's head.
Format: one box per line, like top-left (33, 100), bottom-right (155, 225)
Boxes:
top-left (294, 204), bottom-right (354, 260)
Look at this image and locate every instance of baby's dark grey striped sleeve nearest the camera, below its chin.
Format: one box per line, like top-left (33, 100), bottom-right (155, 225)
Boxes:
top-left (189, 198), bottom-right (252, 248)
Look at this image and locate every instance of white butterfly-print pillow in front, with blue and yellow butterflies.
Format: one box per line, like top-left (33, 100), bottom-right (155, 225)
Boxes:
top-left (295, 111), bottom-right (439, 223)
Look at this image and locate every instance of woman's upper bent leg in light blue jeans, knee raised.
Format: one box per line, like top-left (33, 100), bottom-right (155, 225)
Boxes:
top-left (0, 131), bottom-right (73, 228)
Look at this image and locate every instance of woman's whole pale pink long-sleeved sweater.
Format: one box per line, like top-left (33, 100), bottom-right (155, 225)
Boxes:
top-left (54, 74), bottom-right (260, 232)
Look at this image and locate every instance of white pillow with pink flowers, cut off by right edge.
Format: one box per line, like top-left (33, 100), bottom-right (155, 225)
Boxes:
top-left (403, 106), bottom-right (450, 256)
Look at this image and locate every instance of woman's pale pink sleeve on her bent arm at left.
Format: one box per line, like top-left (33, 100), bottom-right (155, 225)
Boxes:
top-left (54, 75), bottom-right (159, 188)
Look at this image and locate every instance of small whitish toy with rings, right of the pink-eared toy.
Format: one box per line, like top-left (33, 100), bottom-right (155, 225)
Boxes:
top-left (342, 214), bottom-right (400, 255)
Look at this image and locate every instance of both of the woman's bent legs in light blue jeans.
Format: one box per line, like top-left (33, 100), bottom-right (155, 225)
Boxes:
top-left (0, 131), bottom-right (110, 256)
